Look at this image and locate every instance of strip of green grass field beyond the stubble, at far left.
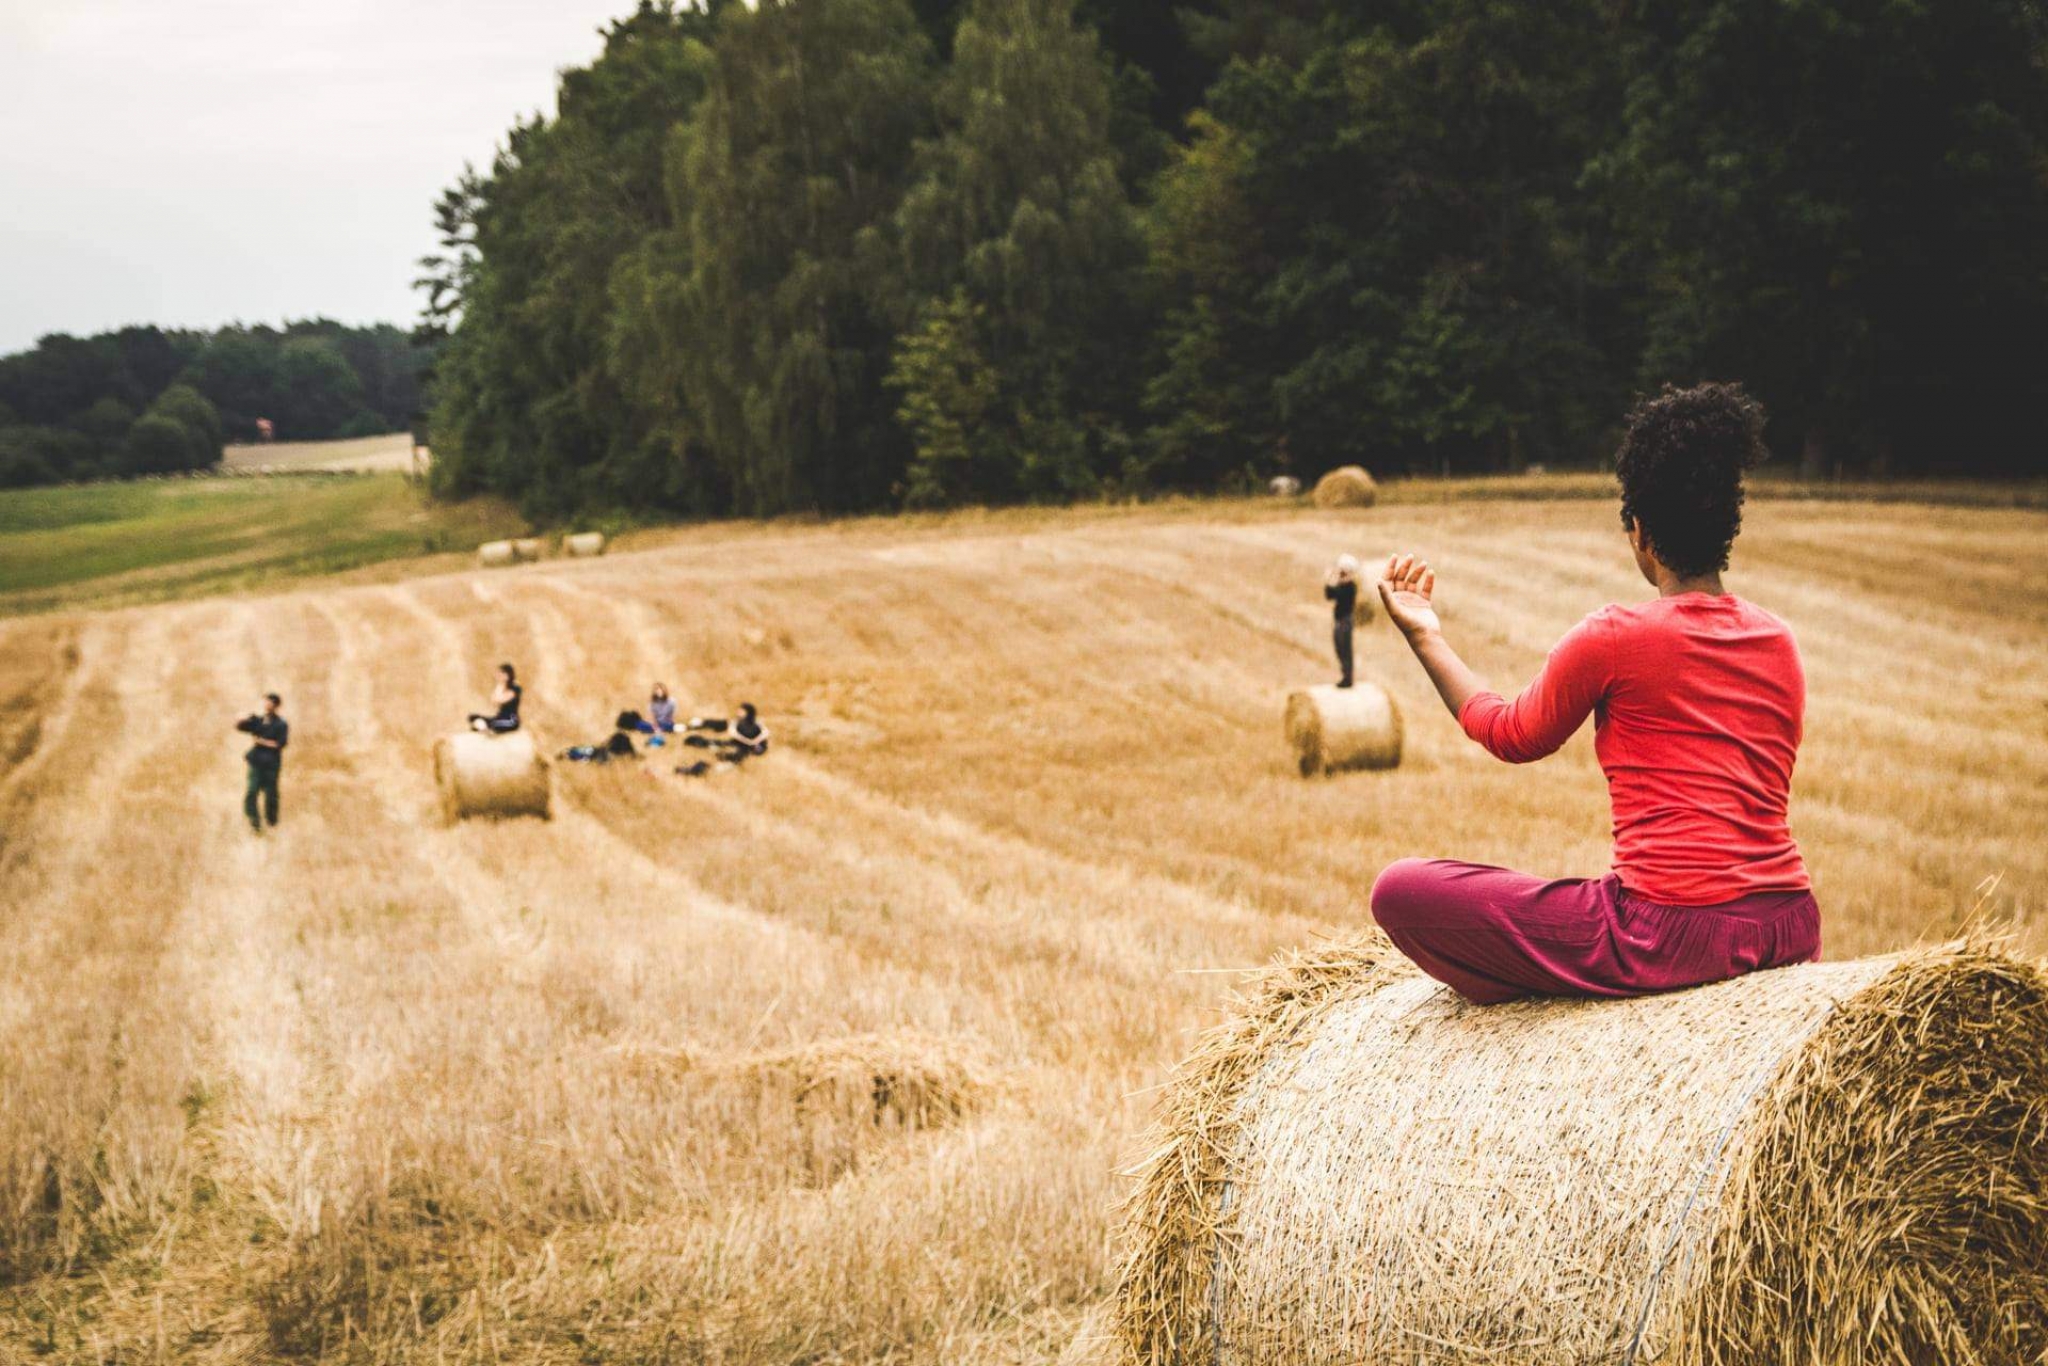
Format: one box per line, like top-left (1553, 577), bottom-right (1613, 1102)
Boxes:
top-left (0, 475), bottom-right (526, 614)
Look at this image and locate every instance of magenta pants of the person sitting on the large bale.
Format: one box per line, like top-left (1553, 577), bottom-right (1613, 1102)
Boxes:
top-left (1372, 858), bottom-right (1821, 1006)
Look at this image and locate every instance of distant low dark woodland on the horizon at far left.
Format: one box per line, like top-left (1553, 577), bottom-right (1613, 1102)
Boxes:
top-left (0, 317), bottom-right (432, 487)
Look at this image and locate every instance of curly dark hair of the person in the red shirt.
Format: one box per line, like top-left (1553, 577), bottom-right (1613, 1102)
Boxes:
top-left (1614, 383), bottom-right (1763, 578)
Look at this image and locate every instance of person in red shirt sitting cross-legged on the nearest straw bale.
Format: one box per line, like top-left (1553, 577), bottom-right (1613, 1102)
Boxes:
top-left (1372, 385), bottom-right (1821, 1004)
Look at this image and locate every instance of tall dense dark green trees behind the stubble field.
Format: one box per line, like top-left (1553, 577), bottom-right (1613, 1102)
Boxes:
top-left (422, 0), bottom-right (2048, 514)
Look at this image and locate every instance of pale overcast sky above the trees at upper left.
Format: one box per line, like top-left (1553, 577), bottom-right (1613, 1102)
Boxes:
top-left (0, 0), bottom-right (633, 352)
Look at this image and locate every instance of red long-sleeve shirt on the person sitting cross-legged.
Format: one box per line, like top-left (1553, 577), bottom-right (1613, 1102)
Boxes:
top-left (1458, 592), bottom-right (1808, 905)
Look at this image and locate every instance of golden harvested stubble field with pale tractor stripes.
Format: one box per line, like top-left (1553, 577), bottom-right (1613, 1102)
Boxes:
top-left (0, 502), bottom-right (2048, 1364)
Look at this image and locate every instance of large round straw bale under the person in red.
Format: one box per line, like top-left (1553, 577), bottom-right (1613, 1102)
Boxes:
top-left (1116, 936), bottom-right (2048, 1366)
